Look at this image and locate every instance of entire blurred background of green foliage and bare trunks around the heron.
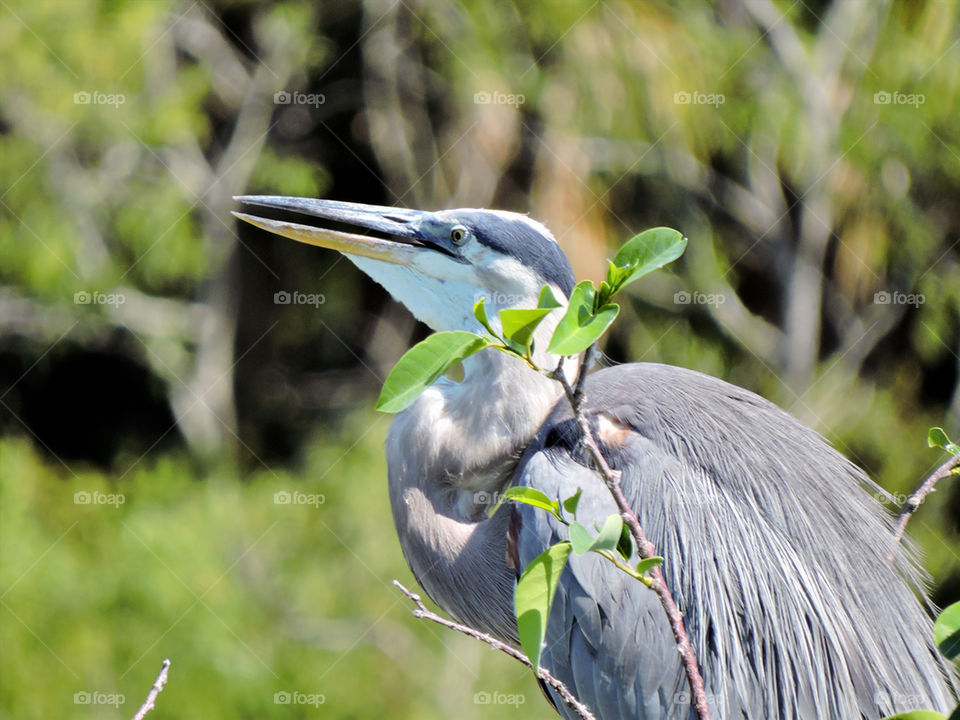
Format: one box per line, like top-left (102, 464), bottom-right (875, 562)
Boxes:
top-left (0, 0), bottom-right (960, 717)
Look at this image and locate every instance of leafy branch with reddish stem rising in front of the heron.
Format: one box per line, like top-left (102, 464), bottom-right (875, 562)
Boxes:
top-left (377, 228), bottom-right (710, 719)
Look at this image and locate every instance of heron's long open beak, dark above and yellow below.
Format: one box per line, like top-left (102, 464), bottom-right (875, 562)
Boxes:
top-left (233, 195), bottom-right (425, 265)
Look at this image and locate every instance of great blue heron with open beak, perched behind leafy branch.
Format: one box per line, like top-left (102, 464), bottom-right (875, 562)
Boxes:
top-left (238, 196), bottom-right (956, 720)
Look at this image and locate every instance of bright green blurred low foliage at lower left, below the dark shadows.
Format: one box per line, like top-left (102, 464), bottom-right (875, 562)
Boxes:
top-left (0, 428), bottom-right (549, 718)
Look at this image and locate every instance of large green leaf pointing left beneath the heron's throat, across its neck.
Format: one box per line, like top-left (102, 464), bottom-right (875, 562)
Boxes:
top-left (377, 331), bottom-right (490, 413)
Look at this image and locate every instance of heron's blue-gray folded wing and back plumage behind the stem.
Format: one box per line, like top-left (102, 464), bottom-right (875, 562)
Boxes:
top-left (516, 364), bottom-right (956, 720)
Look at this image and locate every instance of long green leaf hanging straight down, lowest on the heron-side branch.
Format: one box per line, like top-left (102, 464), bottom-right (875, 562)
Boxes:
top-left (514, 541), bottom-right (570, 671)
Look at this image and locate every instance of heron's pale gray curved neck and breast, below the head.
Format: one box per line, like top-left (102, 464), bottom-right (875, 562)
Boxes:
top-left (387, 349), bottom-right (561, 641)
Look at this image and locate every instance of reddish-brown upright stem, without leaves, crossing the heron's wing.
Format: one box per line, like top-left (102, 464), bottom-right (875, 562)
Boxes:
top-left (553, 345), bottom-right (710, 720)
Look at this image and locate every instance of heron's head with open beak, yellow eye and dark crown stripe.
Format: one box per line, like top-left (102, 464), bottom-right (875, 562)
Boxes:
top-left (234, 195), bottom-right (575, 331)
